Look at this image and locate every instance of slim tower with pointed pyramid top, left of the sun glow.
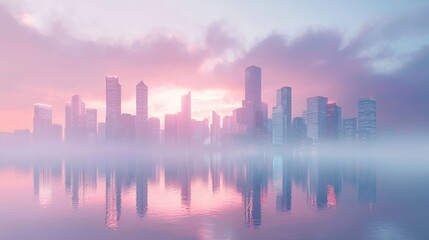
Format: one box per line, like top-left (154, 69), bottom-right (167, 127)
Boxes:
top-left (136, 81), bottom-right (148, 141)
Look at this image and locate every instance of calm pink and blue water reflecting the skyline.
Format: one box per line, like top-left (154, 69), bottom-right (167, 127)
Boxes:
top-left (0, 149), bottom-right (429, 239)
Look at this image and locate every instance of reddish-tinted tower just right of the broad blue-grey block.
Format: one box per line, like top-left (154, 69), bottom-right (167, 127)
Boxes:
top-left (326, 102), bottom-right (342, 141)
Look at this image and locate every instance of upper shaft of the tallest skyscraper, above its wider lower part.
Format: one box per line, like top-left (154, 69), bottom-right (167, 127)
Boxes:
top-left (245, 66), bottom-right (261, 109)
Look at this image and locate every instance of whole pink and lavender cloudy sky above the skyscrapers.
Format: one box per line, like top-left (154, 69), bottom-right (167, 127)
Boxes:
top-left (0, 0), bottom-right (429, 131)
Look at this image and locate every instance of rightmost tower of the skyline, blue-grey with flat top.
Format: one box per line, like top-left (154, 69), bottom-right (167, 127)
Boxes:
top-left (358, 98), bottom-right (377, 141)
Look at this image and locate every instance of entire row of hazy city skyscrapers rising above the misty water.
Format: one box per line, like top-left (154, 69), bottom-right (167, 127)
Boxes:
top-left (0, 66), bottom-right (377, 147)
